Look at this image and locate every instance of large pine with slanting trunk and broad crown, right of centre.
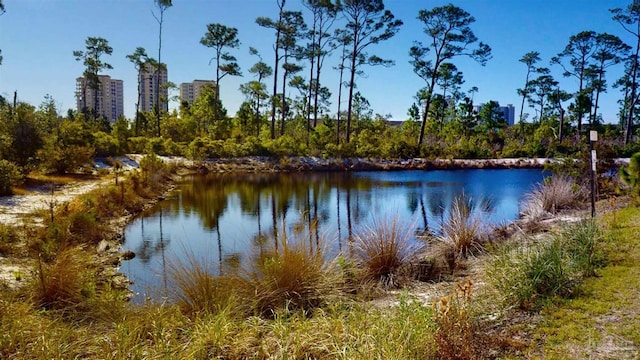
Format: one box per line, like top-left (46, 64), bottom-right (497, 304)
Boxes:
top-left (409, 4), bottom-right (491, 146)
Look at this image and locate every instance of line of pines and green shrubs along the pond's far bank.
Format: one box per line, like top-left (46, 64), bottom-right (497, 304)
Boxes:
top-left (0, 0), bottom-right (640, 194)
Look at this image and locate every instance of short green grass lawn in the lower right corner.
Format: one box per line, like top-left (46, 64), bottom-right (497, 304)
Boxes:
top-left (531, 207), bottom-right (640, 359)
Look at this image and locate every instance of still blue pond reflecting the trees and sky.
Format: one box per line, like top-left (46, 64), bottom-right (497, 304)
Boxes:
top-left (121, 169), bottom-right (545, 301)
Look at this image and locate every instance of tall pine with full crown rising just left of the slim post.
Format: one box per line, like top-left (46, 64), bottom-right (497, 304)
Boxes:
top-left (551, 31), bottom-right (598, 136)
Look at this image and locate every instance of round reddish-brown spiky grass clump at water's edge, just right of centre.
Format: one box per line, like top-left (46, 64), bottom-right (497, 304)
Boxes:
top-left (354, 216), bottom-right (419, 287)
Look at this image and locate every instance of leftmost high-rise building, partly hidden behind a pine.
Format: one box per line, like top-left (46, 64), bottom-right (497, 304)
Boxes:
top-left (76, 75), bottom-right (124, 122)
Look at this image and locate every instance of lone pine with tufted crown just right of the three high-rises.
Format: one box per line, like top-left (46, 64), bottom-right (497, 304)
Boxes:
top-left (200, 24), bottom-right (242, 119)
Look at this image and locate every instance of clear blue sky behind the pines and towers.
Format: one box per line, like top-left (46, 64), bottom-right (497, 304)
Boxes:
top-left (0, 0), bottom-right (634, 122)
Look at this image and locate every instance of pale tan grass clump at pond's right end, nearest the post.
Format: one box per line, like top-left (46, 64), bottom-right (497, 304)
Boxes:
top-left (520, 175), bottom-right (581, 221)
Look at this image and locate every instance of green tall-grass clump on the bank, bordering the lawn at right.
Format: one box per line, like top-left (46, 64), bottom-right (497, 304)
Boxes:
top-left (487, 236), bottom-right (576, 309)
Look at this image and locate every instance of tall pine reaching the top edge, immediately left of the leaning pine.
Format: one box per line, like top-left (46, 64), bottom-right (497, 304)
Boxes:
top-left (342, 0), bottom-right (402, 142)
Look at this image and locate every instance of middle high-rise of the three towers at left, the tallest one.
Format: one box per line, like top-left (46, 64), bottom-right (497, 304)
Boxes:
top-left (138, 63), bottom-right (169, 111)
